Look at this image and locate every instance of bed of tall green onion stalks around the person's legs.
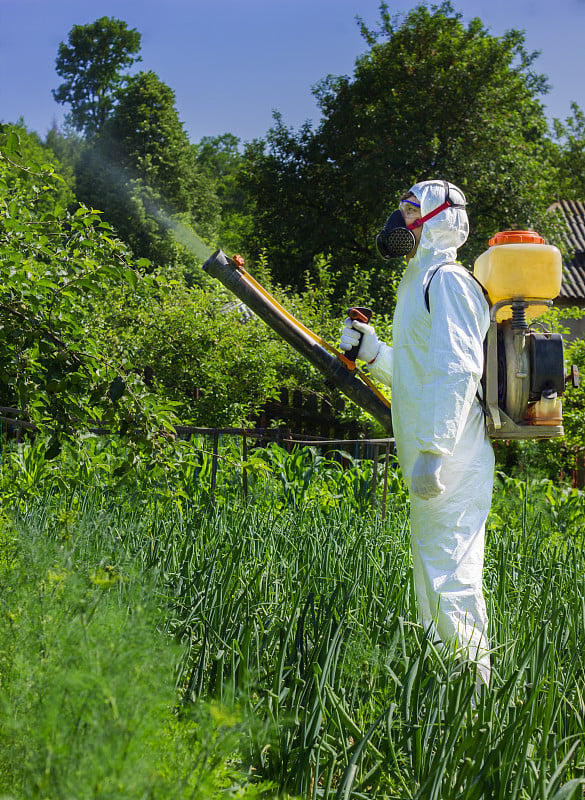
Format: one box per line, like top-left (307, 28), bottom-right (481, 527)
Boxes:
top-left (156, 496), bottom-right (585, 799)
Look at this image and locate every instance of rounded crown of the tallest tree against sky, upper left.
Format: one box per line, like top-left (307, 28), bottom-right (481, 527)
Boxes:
top-left (53, 17), bottom-right (141, 136)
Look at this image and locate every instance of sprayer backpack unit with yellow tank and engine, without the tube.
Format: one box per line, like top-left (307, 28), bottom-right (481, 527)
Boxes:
top-left (473, 231), bottom-right (579, 439)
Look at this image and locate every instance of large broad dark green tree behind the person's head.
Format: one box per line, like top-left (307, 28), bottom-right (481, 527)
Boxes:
top-left (242, 2), bottom-right (554, 306)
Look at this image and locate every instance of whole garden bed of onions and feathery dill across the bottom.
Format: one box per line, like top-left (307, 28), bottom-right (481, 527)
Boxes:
top-left (0, 440), bottom-right (585, 800)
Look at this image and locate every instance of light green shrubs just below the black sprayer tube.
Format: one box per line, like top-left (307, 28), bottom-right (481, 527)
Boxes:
top-left (81, 260), bottom-right (334, 426)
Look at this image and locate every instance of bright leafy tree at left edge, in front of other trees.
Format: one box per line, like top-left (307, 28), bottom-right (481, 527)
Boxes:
top-left (0, 126), bottom-right (171, 470)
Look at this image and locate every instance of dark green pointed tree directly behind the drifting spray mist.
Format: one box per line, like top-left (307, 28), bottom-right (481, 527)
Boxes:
top-left (77, 72), bottom-right (219, 264)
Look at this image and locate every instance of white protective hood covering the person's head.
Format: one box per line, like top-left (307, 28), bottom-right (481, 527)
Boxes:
top-left (409, 180), bottom-right (469, 271)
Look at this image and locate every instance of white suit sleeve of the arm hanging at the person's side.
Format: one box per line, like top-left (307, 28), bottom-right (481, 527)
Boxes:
top-left (417, 266), bottom-right (489, 455)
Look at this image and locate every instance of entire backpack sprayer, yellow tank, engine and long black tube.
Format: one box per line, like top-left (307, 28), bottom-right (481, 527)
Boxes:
top-left (203, 231), bottom-right (579, 439)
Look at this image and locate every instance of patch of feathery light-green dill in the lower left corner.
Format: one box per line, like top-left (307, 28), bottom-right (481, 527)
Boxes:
top-left (0, 491), bottom-right (272, 800)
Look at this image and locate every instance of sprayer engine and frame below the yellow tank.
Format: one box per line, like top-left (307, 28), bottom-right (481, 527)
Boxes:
top-left (482, 298), bottom-right (578, 439)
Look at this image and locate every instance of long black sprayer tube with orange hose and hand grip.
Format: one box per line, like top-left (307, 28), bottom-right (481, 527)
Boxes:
top-left (203, 250), bottom-right (392, 435)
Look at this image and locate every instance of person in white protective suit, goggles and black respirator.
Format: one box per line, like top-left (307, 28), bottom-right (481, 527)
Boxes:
top-left (341, 180), bottom-right (494, 686)
